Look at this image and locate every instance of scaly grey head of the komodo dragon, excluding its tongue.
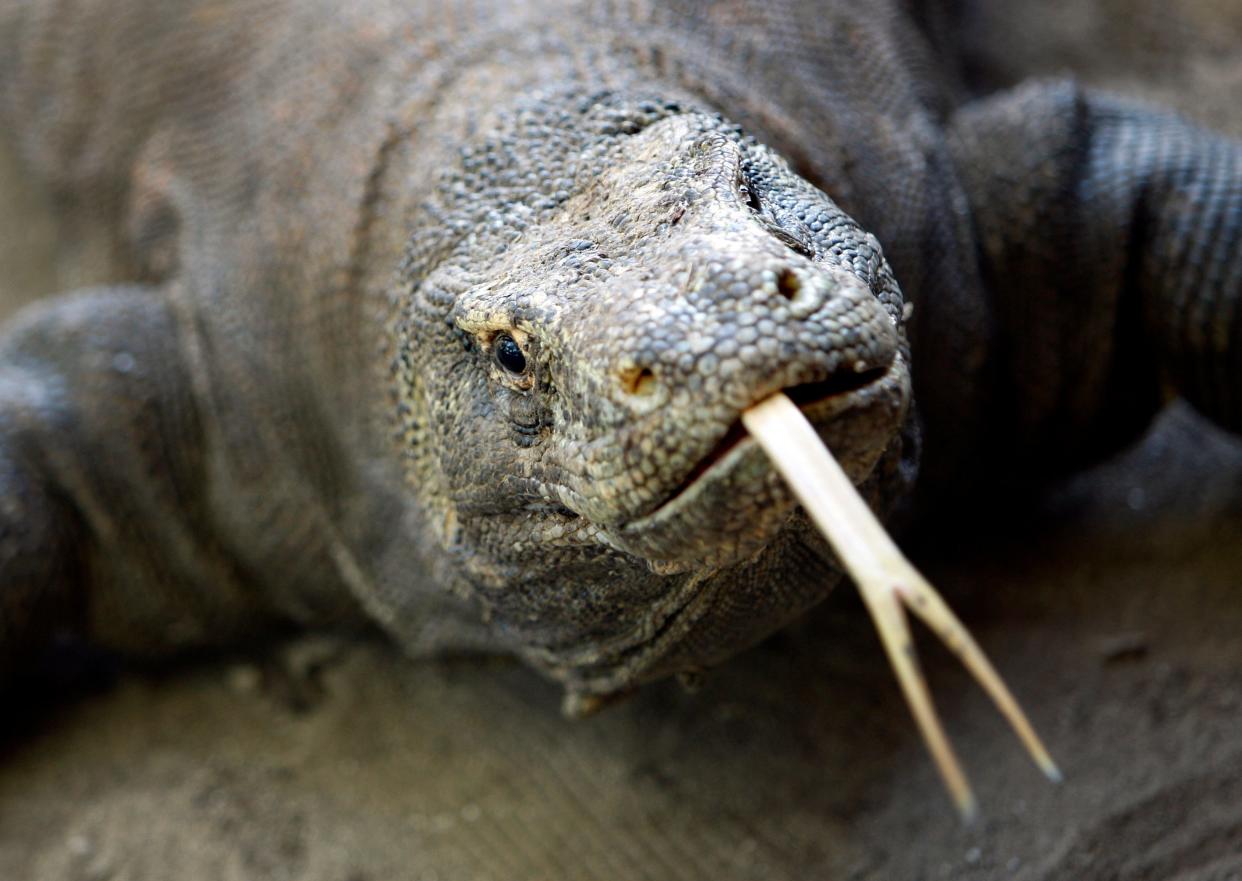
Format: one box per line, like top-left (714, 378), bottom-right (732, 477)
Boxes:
top-left (392, 93), bottom-right (913, 696)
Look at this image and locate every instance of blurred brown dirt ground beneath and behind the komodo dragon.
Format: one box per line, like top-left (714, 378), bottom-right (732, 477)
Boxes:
top-left (0, 0), bottom-right (1242, 881)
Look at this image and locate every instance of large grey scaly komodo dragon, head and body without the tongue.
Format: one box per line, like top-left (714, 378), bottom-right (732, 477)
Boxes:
top-left (0, 0), bottom-right (1242, 805)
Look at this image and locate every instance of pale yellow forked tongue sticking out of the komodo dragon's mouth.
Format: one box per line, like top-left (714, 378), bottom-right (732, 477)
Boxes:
top-left (741, 393), bottom-right (1061, 820)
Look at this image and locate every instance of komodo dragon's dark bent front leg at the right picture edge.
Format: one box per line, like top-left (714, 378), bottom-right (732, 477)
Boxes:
top-left (943, 82), bottom-right (1242, 477)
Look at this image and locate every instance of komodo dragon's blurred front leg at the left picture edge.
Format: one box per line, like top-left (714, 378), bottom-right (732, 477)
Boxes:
top-left (0, 286), bottom-right (269, 680)
